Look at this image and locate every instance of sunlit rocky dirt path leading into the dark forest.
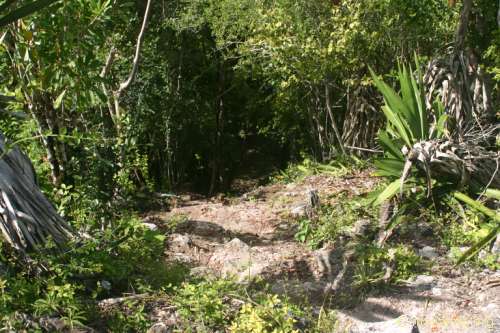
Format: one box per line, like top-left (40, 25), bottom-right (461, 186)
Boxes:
top-left (143, 172), bottom-right (500, 333)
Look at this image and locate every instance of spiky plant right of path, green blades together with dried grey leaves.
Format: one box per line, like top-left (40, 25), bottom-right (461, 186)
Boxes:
top-left (370, 61), bottom-right (500, 262)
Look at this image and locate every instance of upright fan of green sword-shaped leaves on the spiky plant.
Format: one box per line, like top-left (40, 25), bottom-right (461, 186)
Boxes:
top-left (370, 61), bottom-right (446, 204)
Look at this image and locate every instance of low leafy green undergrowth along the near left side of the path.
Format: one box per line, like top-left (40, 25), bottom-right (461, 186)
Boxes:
top-left (0, 210), bottom-right (335, 333)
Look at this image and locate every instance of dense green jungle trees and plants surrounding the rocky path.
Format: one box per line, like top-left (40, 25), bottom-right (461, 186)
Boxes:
top-left (0, 0), bottom-right (500, 333)
